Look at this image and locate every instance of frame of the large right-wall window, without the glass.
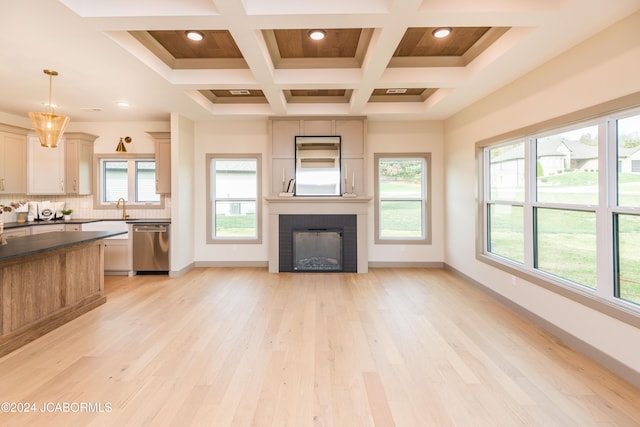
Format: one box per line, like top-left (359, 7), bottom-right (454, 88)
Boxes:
top-left (476, 93), bottom-right (640, 327)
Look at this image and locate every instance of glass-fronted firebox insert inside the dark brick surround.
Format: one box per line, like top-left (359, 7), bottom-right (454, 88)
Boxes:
top-left (293, 228), bottom-right (343, 271)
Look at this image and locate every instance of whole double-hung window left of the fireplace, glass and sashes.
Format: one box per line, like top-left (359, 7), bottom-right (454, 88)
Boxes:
top-left (207, 154), bottom-right (261, 243)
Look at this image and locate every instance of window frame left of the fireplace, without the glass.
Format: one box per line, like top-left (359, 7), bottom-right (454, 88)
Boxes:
top-left (205, 153), bottom-right (263, 244)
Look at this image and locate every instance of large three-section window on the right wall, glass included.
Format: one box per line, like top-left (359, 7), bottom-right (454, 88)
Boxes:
top-left (478, 106), bottom-right (640, 313)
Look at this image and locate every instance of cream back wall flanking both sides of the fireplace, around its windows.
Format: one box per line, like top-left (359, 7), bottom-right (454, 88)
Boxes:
top-left (191, 120), bottom-right (444, 264)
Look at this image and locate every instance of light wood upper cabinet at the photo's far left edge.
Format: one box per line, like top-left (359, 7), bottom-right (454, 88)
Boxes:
top-left (0, 125), bottom-right (28, 194)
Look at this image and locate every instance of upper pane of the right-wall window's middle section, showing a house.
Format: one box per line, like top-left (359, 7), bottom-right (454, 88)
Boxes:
top-left (536, 126), bottom-right (598, 205)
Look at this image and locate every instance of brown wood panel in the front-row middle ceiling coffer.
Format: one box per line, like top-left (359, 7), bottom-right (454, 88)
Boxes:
top-left (273, 28), bottom-right (362, 58)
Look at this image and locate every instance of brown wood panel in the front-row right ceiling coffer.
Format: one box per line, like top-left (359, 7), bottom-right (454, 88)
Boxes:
top-left (393, 27), bottom-right (490, 57)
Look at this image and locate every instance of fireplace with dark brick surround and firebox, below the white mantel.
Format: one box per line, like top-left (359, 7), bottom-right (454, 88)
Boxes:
top-left (278, 215), bottom-right (358, 273)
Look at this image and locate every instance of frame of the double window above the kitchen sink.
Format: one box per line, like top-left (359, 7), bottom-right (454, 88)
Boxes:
top-left (93, 153), bottom-right (165, 209)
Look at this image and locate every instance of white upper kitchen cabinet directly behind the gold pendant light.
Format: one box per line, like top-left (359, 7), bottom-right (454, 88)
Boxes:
top-left (27, 135), bottom-right (65, 195)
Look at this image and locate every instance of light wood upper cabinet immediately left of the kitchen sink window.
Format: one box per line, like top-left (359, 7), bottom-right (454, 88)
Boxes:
top-left (64, 132), bottom-right (98, 196)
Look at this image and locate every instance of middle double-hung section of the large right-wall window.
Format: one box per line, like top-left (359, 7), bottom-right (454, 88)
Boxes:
top-left (531, 125), bottom-right (599, 289)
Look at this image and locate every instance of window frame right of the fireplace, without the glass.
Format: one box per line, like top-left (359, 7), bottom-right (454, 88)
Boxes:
top-left (373, 152), bottom-right (432, 245)
